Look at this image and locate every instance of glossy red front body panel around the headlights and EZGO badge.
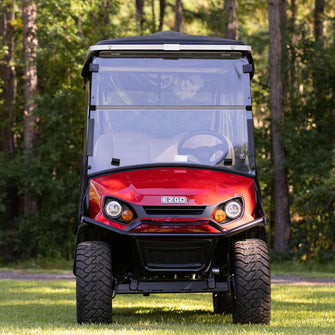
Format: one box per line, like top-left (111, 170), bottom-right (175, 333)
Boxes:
top-left (89, 168), bottom-right (255, 232)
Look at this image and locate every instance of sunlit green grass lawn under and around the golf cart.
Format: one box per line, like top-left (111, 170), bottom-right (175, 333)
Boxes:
top-left (0, 280), bottom-right (335, 335)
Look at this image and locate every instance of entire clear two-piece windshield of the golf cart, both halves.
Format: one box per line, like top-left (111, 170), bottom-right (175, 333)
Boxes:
top-left (88, 58), bottom-right (255, 174)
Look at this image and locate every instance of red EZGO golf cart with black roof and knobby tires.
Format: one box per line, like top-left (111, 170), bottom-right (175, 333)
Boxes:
top-left (74, 32), bottom-right (271, 324)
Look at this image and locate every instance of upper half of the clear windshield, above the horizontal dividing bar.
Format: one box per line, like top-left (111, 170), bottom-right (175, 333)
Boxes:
top-left (91, 57), bottom-right (251, 106)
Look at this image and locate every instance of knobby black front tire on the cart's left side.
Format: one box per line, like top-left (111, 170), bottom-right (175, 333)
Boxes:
top-left (76, 241), bottom-right (113, 323)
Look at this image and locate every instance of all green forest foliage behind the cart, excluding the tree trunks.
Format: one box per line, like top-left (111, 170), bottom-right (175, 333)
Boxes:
top-left (0, 0), bottom-right (335, 262)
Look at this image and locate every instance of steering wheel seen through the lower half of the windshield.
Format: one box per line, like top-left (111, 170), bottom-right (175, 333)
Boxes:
top-left (178, 130), bottom-right (229, 165)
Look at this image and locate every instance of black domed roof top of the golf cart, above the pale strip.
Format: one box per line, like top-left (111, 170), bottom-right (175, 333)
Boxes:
top-left (96, 31), bottom-right (244, 45)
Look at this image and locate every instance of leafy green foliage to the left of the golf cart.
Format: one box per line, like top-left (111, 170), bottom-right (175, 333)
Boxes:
top-left (0, 0), bottom-right (123, 260)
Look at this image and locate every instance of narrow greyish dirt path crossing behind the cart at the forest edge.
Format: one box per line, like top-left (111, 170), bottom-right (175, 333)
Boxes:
top-left (0, 271), bottom-right (335, 286)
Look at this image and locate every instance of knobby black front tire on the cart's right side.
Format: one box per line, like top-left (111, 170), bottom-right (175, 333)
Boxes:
top-left (233, 238), bottom-right (271, 324)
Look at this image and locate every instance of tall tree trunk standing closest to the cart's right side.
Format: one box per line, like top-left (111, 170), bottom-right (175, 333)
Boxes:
top-left (268, 0), bottom-right (290, 252)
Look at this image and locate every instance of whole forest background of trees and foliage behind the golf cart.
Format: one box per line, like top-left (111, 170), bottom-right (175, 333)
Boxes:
top-left (0, 0), bottom-right (335, 263)
